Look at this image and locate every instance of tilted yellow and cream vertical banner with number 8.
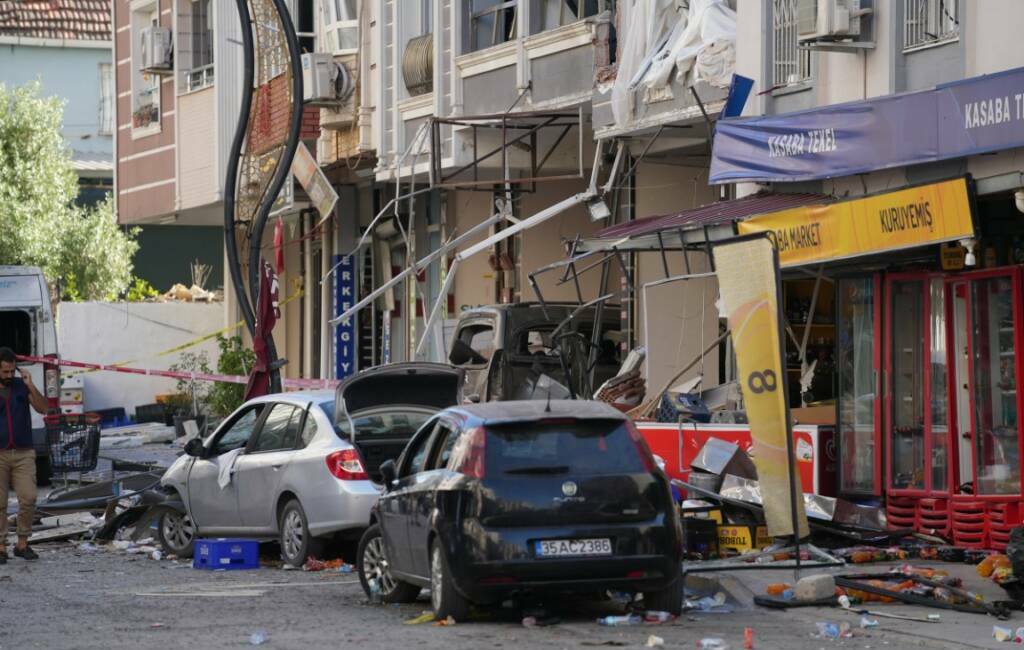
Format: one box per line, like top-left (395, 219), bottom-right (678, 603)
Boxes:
top-left (714, 236), bottom-right (808, 537)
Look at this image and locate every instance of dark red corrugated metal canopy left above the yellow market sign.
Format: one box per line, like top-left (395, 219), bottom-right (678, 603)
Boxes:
top-left (591, 193), bottom-right (833, 240)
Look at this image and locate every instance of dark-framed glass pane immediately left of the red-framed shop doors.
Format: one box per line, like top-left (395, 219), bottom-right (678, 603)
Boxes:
top-left (836, 277), bottom-right (878, 494)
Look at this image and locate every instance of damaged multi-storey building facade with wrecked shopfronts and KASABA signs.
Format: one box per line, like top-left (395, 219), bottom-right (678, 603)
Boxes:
top-left (116, 0), bottom-right (1024, 547)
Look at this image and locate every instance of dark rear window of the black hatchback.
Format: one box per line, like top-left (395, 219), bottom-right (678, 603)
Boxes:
top-left (486, 420), bottom-right (647, 475)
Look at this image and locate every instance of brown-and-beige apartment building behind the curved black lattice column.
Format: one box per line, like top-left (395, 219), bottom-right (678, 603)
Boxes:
top-left (113, 0), bottom-right (330, 377)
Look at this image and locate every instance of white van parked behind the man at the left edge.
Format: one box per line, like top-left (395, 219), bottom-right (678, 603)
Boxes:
top-left (0, 266), bottom-right (60, 456)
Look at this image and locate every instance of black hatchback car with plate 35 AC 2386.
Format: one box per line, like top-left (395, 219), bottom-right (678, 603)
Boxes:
top-left (357, 401), bottom-right (683, 620)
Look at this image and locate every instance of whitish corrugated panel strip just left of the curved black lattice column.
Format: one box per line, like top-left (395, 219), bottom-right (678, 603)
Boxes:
top-left (213, 2), bottom-right (243, 191)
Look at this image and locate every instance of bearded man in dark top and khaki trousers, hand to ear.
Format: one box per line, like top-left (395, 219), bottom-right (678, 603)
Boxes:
top-left (0, 347), bottom-right (47, 564)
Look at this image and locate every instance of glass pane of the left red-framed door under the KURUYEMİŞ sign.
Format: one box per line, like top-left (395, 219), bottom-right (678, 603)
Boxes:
top-left (891, 280), bottom-right (925, 489)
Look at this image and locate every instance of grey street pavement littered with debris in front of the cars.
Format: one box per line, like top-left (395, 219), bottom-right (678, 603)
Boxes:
top-left (0, 544), bottom-right (1007, 650)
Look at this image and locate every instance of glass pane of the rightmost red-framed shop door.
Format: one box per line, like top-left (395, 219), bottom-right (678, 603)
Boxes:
top-left (971, 277), bottom-right (1021, 494)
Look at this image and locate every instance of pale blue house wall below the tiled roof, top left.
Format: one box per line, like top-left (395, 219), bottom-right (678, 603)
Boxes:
top-left (0, 41), bottom-right (113, 156)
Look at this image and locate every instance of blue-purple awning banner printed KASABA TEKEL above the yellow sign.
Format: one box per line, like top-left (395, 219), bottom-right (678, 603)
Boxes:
top-left (711, 68), bottom-right (1024, 183)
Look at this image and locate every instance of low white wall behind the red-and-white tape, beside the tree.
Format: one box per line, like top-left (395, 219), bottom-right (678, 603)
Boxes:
top-left (57, 302), bottom-right (223, 414)
